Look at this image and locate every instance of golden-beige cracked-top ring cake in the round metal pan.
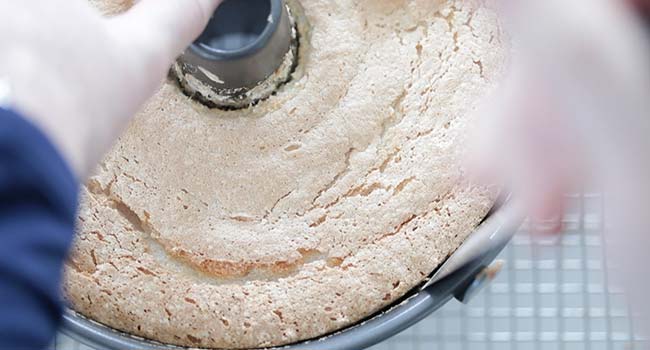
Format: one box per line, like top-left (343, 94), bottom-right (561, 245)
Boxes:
top-left (65, 0), bottom-right (505, 348)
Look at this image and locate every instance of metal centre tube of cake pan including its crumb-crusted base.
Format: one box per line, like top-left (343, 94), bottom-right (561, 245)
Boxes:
top-left (172, 0), bottom-right (298, 109)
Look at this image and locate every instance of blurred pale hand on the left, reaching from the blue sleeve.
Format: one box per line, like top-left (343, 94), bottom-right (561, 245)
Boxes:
top-left (0, 0), bottom-right (221, 179)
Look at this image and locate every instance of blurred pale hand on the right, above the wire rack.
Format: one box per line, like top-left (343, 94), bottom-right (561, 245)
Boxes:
top-left (473, 0), bottom-right (650, 233)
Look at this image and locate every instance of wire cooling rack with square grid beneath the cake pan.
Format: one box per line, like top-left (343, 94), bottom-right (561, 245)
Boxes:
top-left (54, 194), bottom-right (650, 350)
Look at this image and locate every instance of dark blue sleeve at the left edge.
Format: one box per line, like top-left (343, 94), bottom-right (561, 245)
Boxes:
top-left (0, 109), bottom-right (78, 350)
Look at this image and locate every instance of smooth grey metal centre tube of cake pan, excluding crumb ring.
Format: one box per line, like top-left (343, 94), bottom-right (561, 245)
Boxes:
top-left (180, 0), bottom-right (291, 90)
